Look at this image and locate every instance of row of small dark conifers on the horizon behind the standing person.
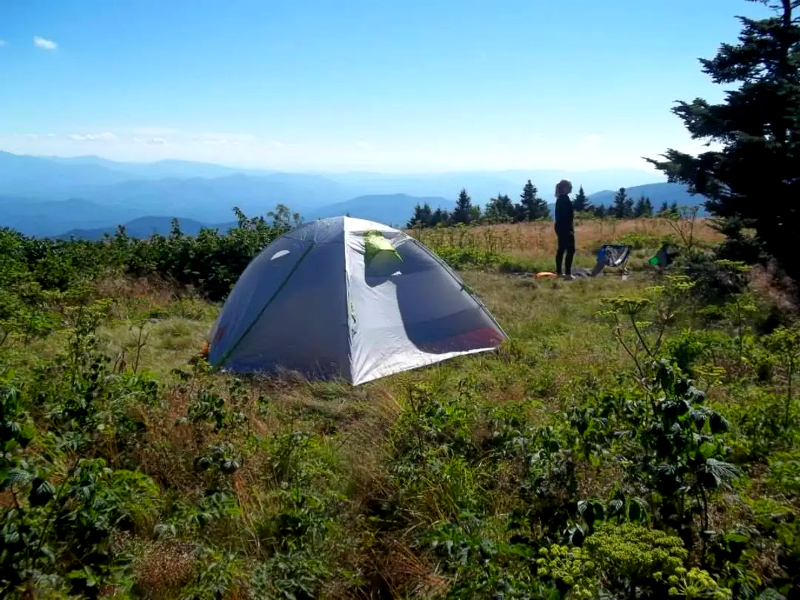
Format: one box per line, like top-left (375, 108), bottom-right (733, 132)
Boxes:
top-left (406, 179), bottom-right (678, 228)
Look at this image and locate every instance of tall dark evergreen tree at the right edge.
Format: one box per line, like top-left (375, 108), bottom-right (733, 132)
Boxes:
top-left (648, 0), bottom-right (800, 279)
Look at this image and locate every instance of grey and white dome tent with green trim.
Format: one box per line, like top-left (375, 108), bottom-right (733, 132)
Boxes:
top-left (208, 217), bottom-right (506, 385)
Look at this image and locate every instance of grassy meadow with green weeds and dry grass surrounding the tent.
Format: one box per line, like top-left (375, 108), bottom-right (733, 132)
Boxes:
top-left (0, 219), bottom-right (800, 599)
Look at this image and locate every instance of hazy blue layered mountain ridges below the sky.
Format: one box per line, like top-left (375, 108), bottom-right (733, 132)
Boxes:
top-left (0, 151), bottom-right (699, 236)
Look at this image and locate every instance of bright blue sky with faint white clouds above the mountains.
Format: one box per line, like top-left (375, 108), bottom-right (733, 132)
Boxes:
top-left (0, 0), bottom-right (764, 171)
